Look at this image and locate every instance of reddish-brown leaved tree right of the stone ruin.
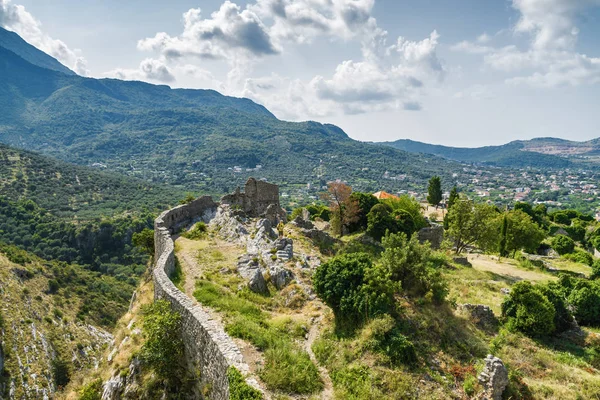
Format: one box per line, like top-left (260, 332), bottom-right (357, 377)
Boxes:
top-left (321, 182), bottom-right (359, 236)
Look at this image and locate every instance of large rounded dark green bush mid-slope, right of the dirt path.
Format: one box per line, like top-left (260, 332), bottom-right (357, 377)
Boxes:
top-left (313, 253), bottom-right (395, 321)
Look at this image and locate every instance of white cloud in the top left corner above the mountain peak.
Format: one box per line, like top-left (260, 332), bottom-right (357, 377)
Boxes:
top-left (0, 0), bottom-right (89, 75)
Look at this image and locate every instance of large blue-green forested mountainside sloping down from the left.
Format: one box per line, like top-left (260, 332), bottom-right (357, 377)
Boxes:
top-left (0, 29), bottom-right (458, 193)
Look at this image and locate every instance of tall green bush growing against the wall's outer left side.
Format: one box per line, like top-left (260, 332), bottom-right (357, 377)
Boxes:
top-left (140, 300), bottom-right (183, 386)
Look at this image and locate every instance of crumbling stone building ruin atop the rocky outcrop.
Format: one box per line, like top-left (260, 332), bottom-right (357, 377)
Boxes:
top-left (221, 178), bottom-right (281, 217)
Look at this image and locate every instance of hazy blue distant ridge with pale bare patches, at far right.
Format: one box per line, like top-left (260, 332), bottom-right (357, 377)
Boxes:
top-left (380, 137), bottom-right (600, 168)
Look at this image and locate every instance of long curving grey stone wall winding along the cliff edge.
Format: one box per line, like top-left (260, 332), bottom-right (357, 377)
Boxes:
top-left (153, 196), bottom-right (248, 400)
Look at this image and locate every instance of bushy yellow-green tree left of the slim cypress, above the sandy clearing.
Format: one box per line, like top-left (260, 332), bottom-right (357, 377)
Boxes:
top-left (448, 198), bottom-right (497, 254)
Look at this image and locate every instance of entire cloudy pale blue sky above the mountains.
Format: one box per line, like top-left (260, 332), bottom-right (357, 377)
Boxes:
top-left (0, 0), bottom-right (600, 147)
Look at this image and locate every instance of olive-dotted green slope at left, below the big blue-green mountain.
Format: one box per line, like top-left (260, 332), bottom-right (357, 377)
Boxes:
top-left (0, 144), bottom-right (185, 220)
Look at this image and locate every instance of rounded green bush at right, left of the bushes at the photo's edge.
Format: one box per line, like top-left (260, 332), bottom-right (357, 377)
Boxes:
top-left (502, 281), bottom-right (556, 337)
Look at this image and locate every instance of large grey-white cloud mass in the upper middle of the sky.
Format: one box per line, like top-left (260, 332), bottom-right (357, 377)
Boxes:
top-left (135, 0), bottom-right (445, 119)
